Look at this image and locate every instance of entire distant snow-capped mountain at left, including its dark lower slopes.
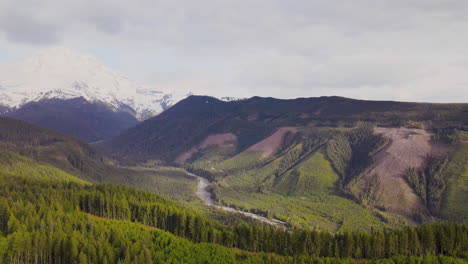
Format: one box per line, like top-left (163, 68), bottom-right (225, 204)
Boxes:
top-left (0, 47), bottom-right (194, 141)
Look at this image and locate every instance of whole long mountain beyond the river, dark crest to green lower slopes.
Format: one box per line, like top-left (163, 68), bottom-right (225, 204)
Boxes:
top-left (98, 96), bottom-right (468, 227)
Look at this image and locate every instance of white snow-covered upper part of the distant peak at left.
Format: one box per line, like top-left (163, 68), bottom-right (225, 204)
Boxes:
top-left (0, 47), bottom-right (185, 120)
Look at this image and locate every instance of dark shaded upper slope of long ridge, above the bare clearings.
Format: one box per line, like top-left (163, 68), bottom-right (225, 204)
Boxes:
top-left (102, 96), bottom-right (468, 163)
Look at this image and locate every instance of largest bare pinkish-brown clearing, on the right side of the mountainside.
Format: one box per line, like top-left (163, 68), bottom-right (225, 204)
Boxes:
top-left (358, 127), bottom-right (446, 220)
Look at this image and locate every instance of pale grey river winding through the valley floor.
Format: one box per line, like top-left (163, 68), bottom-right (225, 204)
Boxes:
top-left (187, 172), bottom-right (285, 228)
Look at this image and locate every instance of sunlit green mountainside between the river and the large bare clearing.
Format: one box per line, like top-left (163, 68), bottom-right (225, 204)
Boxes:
top-left (207, 126), bottom-right (386, 231)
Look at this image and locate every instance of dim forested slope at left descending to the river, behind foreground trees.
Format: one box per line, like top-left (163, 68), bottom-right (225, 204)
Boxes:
top-left (0, 117), bottom-right (203, 201)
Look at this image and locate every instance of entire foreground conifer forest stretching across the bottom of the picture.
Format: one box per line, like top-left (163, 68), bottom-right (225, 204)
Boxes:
top-left (0, 172), bottom-right (468, 263)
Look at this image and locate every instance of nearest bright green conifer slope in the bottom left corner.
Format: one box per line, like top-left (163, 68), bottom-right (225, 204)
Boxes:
top-left (0, 193), bottom-right (260, 264)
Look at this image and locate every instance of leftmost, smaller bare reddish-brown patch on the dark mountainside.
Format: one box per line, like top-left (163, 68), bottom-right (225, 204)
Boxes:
top-left (175, 133), bottom-right (237, 165)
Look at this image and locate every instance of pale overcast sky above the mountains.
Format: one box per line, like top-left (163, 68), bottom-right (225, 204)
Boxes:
top-left (0, 0), bottom-right (468, 102)
